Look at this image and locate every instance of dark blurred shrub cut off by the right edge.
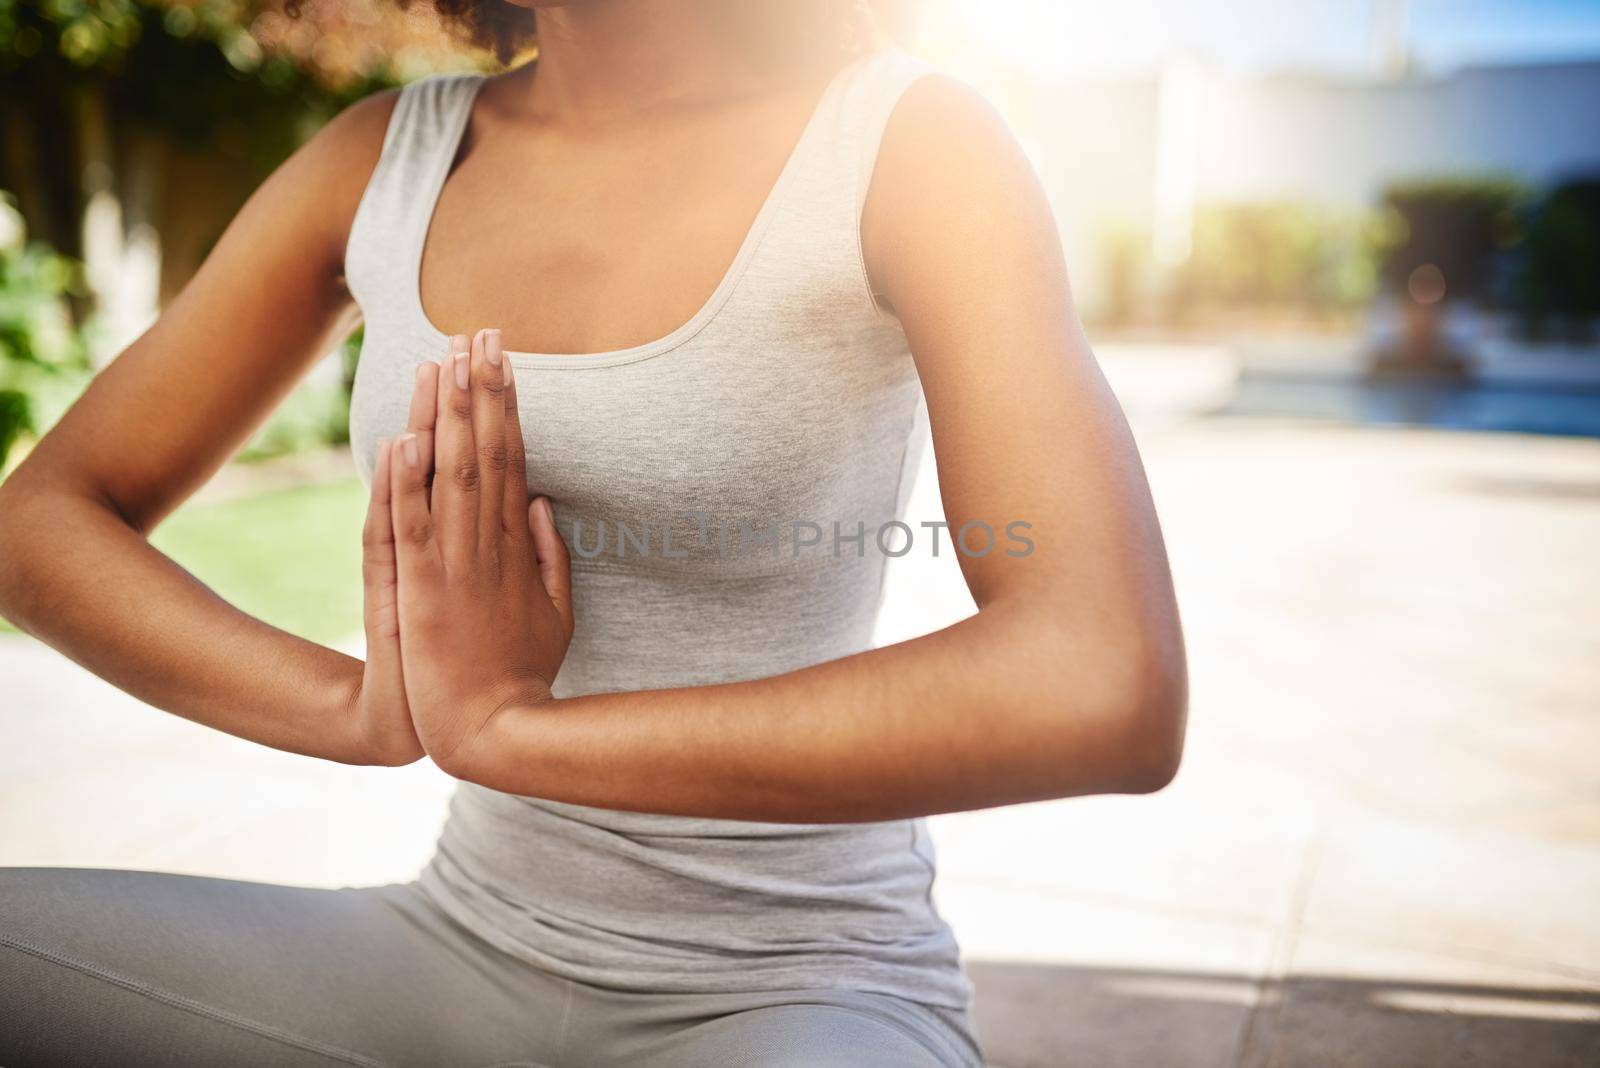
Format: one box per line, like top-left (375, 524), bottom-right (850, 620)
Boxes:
top-left (1512, 179), bottom-right (1600, 342)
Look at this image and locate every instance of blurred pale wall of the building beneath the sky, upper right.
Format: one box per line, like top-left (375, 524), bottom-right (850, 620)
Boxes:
top-left (984, 59), bottom-right (1600, 317)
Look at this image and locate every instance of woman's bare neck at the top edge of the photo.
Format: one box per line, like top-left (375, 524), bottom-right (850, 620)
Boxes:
top-left (530, 0), bottom-right (851, 120)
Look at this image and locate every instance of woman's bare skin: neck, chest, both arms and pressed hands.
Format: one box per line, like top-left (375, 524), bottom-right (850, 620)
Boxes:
top-left (0, 0), bottom-right (1186, 822)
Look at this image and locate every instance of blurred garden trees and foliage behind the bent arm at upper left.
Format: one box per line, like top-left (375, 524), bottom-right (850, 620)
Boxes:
top-left (0, 0), bottom-right (467, 462)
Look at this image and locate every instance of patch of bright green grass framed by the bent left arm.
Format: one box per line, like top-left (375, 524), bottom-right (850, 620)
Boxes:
top-left (0, 478), bottom-right (366, 644)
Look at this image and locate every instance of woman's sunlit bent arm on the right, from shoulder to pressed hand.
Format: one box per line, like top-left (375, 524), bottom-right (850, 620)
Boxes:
top-left (394, 78), bottom-right (1187, 822)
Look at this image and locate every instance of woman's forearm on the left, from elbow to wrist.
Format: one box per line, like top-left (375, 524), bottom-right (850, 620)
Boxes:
top-left (0, 486), bottom-right (366, 763)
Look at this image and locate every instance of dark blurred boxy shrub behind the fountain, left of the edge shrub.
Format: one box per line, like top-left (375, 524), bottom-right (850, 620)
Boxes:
top-left (1382, 176), bottom-right (1528, 304)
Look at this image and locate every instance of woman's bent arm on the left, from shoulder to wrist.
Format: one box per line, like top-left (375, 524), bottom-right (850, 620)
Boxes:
top-left (0, 94), bottom-right (419, 763)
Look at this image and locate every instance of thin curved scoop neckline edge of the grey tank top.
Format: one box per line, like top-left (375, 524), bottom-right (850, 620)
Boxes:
top-left (408, 53), bottom-right (870, 368)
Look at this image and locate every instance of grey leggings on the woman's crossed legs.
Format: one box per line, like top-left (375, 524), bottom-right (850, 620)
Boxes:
top-left (0, 868), bottom-right (981, 1068)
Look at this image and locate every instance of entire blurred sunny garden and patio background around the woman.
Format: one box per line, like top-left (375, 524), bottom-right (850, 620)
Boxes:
top-left (0, 0), bottom-right (1600, 1068)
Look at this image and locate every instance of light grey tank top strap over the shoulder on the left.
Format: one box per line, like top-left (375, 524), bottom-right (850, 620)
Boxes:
top-left (344, 74), bottom-right (483, 320)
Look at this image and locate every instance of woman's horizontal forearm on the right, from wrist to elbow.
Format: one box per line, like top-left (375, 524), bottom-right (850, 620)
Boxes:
top-left (451, 606), bottom-right (1182, 822)
